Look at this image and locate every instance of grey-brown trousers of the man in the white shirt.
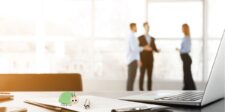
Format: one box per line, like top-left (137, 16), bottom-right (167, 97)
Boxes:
top-left (127, 60), bottom-right (137, 91)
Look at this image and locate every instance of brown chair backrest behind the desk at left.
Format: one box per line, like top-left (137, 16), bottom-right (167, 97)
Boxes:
top-left (0, 73), bottom-right (82, 91)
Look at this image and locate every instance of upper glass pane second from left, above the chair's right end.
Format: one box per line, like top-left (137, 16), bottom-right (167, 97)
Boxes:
top-left (43, 0), bottom-right (92, 38)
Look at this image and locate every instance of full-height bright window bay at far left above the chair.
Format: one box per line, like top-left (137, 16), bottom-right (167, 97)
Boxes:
top-left (0, 0), bottom-right (37, 73)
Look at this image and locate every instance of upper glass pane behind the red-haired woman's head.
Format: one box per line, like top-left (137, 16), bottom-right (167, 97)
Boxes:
top-left (148, 0), bottom-right (203, 38)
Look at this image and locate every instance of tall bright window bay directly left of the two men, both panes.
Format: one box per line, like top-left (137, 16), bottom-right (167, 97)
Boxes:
top-left (93, 0), bottom-right (146, 80)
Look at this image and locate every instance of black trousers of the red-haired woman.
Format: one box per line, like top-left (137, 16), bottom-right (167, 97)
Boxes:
top-left (181, 54), bottom-right (196, 90)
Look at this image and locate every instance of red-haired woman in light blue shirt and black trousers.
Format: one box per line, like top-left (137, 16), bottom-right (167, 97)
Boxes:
top-left (177, 24), bottom-right (196, 90)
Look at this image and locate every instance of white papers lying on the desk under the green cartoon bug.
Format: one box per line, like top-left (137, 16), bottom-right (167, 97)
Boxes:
top-left (25, 96), bottom-right (159, 112)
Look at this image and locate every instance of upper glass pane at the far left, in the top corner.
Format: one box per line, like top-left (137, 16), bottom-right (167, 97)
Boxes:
top-left (0, 0), bottom-right (37, 38)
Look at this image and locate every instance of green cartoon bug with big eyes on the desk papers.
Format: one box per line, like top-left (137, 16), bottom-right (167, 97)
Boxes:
top-left (59, 92), bottom-right (78, 106)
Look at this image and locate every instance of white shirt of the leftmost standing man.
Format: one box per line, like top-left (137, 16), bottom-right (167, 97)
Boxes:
top-left (127, 32), bottom-right (140, 64)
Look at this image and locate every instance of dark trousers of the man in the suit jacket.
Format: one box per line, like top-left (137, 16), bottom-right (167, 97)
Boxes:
top-left (139, 61), bottom-right (153, 91)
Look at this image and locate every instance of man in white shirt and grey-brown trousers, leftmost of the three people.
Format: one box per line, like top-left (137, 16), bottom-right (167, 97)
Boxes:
top-left (127, 23), bottom-right (141, 91)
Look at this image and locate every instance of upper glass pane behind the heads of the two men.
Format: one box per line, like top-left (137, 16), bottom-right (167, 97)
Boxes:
top-left (94, 0), bottom-right (146, 38)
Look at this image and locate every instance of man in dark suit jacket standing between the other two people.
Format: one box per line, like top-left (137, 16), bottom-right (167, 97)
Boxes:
top-left (138, 22), bottom-right (159, 91)
